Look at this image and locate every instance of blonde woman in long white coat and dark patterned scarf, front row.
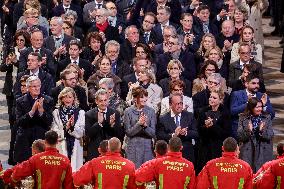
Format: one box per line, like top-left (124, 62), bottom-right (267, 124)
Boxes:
top-left (52, 87), bottom-right (85, 172)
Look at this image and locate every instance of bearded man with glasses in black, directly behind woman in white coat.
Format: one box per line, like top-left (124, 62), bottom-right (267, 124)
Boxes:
top-left (51, 69), bottom-right (89, 111)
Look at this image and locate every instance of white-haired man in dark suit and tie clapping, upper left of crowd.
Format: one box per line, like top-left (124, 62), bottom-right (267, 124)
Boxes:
top-left (43, 17), bottom-right (74, 60)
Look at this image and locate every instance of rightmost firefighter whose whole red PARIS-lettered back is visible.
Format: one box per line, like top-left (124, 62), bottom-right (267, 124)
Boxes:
top-left (196, 137), bottom-right (253, 189)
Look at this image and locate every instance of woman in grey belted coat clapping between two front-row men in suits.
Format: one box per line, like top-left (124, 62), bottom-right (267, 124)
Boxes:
top-left (124, 86), bottom-right (156, 168)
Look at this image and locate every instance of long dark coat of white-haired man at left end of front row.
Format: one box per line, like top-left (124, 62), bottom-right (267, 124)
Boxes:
top-left (14, 93), bottom-right (54, 163)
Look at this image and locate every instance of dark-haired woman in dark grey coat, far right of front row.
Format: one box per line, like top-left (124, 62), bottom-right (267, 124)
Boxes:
top-left (238, 97), bottom-right (274, 173)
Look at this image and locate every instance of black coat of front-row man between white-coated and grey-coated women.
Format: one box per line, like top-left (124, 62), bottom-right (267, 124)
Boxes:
top-left (85, 107), bottom-right (124, 161)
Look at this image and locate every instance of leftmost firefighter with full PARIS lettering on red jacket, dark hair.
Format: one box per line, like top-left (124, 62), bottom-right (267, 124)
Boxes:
top-left (12, 131), bottom-right (73, 189)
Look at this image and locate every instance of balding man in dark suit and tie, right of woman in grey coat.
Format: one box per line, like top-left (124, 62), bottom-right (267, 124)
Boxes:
top-left (156, 93), bottom-right (198, 163)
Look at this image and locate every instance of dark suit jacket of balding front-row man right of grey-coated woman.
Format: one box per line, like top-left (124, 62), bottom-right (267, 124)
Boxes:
top-left (156, 111), bottom-right (198, 163)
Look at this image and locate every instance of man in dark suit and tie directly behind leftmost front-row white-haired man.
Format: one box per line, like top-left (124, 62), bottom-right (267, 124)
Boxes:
top-left (14, 52), bottom-right (55, 99)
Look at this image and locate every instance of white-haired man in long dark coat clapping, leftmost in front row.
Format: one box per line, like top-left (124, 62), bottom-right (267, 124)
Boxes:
top-left (14, 76), bottom-right (54, 163)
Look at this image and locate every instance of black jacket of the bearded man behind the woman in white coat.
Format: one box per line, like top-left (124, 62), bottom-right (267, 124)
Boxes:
top-left (51, 84), bottom-right (89, 111)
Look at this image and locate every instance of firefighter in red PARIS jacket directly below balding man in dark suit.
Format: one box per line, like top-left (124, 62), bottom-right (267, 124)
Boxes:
top-left (135, 137), bottom-right (195, 189)
